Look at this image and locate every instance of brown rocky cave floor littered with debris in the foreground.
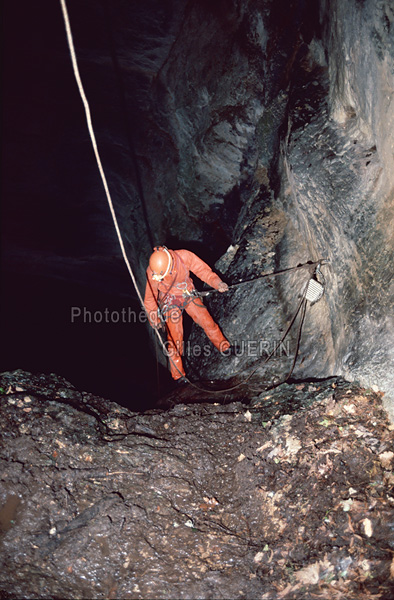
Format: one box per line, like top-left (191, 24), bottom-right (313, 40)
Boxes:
top-left (0, 371), bottom-right (394, 600)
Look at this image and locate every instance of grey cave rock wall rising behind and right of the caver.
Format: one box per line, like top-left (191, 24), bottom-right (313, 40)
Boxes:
top-left (111, 1), bottom-right (394, 412)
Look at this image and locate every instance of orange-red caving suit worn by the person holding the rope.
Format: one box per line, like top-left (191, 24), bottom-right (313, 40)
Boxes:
top-left (144, 250), bottom-right (230, 379)
